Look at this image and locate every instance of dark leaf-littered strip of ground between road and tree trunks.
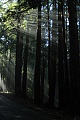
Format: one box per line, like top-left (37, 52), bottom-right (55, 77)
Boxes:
top-left (0, 93), bottom-right (80, 120)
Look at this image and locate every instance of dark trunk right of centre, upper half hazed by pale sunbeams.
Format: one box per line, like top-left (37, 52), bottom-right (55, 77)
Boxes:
top-left (48, 0), bottom-right (56, 108)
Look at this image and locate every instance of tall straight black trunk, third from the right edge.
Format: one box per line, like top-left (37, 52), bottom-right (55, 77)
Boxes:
top-left (58, 0), bottom-right (65, 108)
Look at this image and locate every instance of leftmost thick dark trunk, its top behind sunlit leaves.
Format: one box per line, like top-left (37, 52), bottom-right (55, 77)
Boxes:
top-left (15, 0), bottom-right (23, 96)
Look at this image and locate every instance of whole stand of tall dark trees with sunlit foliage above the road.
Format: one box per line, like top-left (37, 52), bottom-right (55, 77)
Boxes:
top-left (0, 0), bottom-right (80, 116)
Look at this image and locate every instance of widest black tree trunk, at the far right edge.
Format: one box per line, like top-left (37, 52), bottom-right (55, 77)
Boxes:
top-left (68, 0), bottom-right (79, 112)
